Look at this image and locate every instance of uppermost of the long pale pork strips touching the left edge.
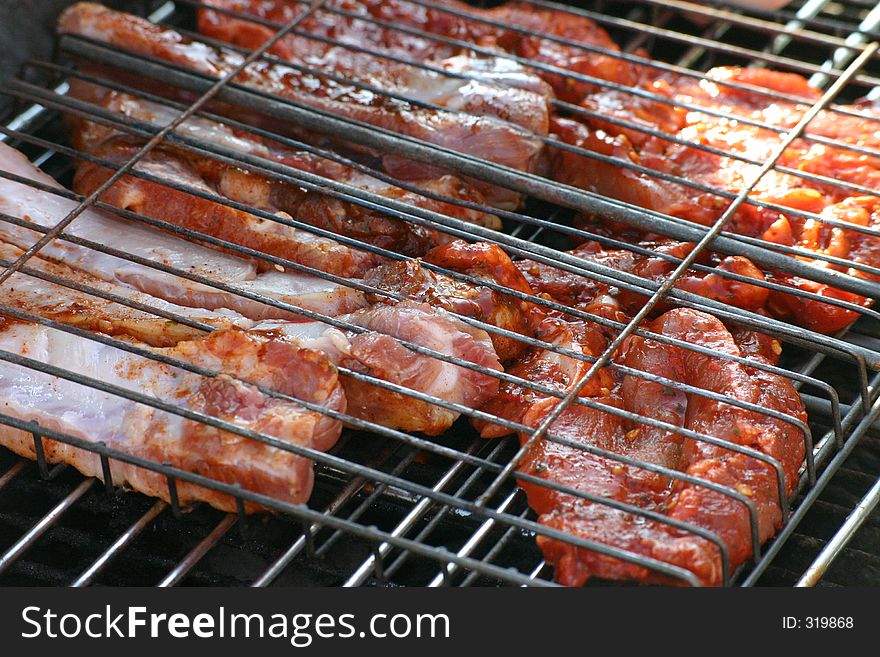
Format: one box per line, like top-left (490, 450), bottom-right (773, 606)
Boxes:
top-left (0, 144), bottom-right (366, 320)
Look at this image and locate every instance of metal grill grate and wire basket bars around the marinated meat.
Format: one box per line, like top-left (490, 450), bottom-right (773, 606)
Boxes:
top-left (0, 0), bottom-right (880, 585)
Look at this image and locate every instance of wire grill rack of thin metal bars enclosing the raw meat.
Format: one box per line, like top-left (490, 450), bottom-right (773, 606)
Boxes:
top-left (0, 0), bottom-right (880, 586)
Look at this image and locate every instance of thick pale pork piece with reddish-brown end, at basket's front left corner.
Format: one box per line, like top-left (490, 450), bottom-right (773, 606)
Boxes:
top-left (0, 318), bottom-right (344, 511)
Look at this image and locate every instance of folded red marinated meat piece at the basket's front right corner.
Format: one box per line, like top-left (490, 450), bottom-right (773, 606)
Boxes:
top-left (483, 309), bottom-right (806, 585)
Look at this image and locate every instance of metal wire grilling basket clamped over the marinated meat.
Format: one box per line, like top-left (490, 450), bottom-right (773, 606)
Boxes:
top-left (0, 0), bottom-right (880, 585)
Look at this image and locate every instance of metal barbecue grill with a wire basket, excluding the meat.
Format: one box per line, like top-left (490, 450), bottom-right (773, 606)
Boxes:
top-left (0, 0), bottom-right (880, 586)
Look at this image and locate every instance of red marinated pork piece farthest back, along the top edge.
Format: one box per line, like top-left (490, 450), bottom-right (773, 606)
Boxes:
top-left (199, 0), bottom-right (632, 101)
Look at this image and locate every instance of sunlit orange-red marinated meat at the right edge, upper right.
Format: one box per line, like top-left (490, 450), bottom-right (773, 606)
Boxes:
top-left (551, 67), bottom-right (880, 333)
